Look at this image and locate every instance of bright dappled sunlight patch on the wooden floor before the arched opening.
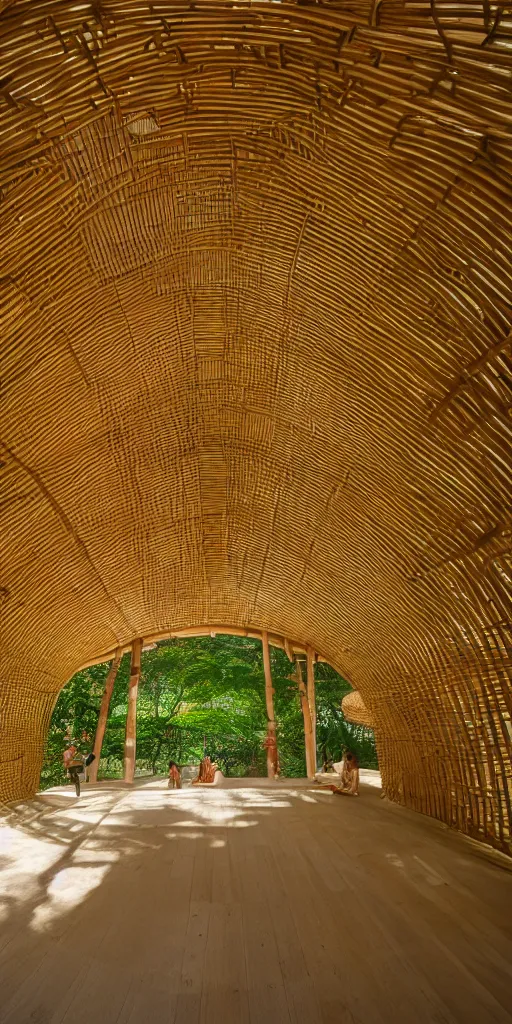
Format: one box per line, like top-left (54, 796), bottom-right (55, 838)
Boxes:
top-left (0, 772), bottom-right (380, 934)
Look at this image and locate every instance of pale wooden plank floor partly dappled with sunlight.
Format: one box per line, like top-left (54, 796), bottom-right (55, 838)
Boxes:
top-left (0, 780), bottom-right (512, 1024)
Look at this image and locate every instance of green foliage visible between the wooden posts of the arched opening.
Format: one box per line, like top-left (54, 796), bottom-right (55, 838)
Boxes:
top-left (41, 636), bottom-right (377, 788)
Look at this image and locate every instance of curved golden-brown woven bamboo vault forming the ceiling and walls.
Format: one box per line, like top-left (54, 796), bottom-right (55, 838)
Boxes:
top-left (0, 0), bottom-right (512, 848)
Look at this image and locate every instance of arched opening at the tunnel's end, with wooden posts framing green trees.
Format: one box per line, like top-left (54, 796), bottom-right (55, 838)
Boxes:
top-left (41, 627), bottom-right (377, 790)
